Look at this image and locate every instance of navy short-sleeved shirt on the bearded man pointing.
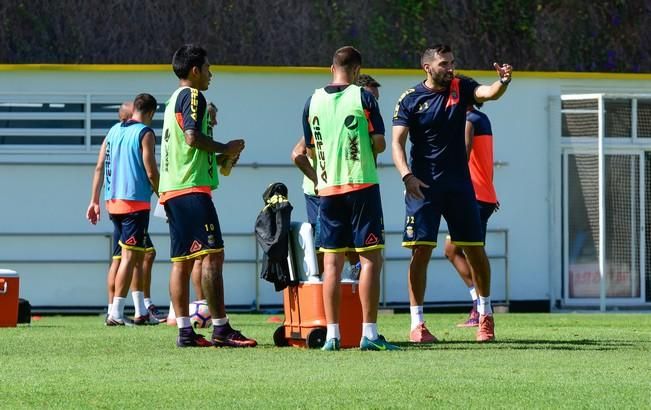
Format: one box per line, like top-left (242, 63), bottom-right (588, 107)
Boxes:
top-left (393, 78), bottom-right (479, 188)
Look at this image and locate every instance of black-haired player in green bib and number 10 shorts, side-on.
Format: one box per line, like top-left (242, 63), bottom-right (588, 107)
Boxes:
top-left (159, 44), bottom-right (257, 347)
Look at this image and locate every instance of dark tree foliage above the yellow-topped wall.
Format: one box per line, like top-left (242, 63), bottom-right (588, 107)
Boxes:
top-left (0, 0), bottom-right (651, 72)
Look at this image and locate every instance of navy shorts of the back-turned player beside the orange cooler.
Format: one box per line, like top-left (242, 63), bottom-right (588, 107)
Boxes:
top-left (319, 184), bottom-right (384, 252)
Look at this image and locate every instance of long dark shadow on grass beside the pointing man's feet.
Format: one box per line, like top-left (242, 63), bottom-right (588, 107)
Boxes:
top-left (394, 339), bottom-right (642, 351)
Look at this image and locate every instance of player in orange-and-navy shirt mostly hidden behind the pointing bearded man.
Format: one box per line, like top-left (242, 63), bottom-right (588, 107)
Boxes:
top-left (445, 103), bottom-right (498, 327)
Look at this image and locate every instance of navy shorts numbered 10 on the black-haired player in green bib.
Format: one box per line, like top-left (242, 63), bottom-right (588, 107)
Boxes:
top-left (165, 193), bottom-right (224, 262)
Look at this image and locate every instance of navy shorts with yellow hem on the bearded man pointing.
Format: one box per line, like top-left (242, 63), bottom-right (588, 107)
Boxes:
top-left (402, 186), bottom-right (486, 248)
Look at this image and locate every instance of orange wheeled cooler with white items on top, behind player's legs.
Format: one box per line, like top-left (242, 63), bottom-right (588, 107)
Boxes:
top-left (274, 222), bottom-right (362, 348)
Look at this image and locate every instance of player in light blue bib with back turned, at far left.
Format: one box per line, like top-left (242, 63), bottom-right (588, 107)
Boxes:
top-left (86, 94), bottom-right (158, 326)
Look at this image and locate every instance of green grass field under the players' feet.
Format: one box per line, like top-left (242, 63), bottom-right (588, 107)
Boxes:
top-left (0, 314), bottom-right (651, 409)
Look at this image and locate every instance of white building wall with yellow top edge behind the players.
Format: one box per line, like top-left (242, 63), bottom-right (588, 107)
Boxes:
top-left (0, 66), bottom-right (646, 307)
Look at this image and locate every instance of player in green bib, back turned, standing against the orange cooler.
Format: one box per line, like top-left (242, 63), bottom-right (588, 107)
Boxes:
top-left (303, 46), bottom-right (398, 350)
